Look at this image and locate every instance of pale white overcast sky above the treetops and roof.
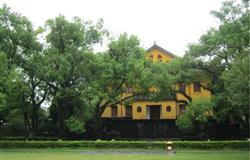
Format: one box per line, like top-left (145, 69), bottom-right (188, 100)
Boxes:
top-left (0, 0), bottom-right (224, 56)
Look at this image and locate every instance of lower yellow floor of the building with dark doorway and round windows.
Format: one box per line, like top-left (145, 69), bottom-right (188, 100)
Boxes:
top-left (102, 100), bottom-right (186, 120)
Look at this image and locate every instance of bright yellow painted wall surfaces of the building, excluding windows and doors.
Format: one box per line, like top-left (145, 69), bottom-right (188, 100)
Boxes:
top-left (102, 45), bottom-right (211, 120)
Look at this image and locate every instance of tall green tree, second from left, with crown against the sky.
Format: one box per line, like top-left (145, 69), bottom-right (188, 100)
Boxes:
top-left (43, 16), bottom-right (107, 136)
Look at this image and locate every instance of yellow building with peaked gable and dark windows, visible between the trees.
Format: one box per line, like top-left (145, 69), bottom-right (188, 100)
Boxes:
top-left (102, 44), bottom-right (210, 120)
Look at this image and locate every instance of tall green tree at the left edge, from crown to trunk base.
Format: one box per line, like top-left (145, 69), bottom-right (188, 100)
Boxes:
top-left (0, 5), bottom-right (47, 138)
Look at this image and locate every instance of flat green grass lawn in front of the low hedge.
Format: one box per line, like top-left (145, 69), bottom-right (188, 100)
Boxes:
top-left (0, 148), bottom-right (249, 160)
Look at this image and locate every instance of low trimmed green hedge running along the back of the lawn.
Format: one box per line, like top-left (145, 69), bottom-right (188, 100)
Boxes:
top-left (0, 140), bottom-right (249, 149)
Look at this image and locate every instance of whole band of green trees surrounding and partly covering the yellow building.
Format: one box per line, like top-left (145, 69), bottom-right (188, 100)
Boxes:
top-left (0, 1), bottom-right (249, 138)
